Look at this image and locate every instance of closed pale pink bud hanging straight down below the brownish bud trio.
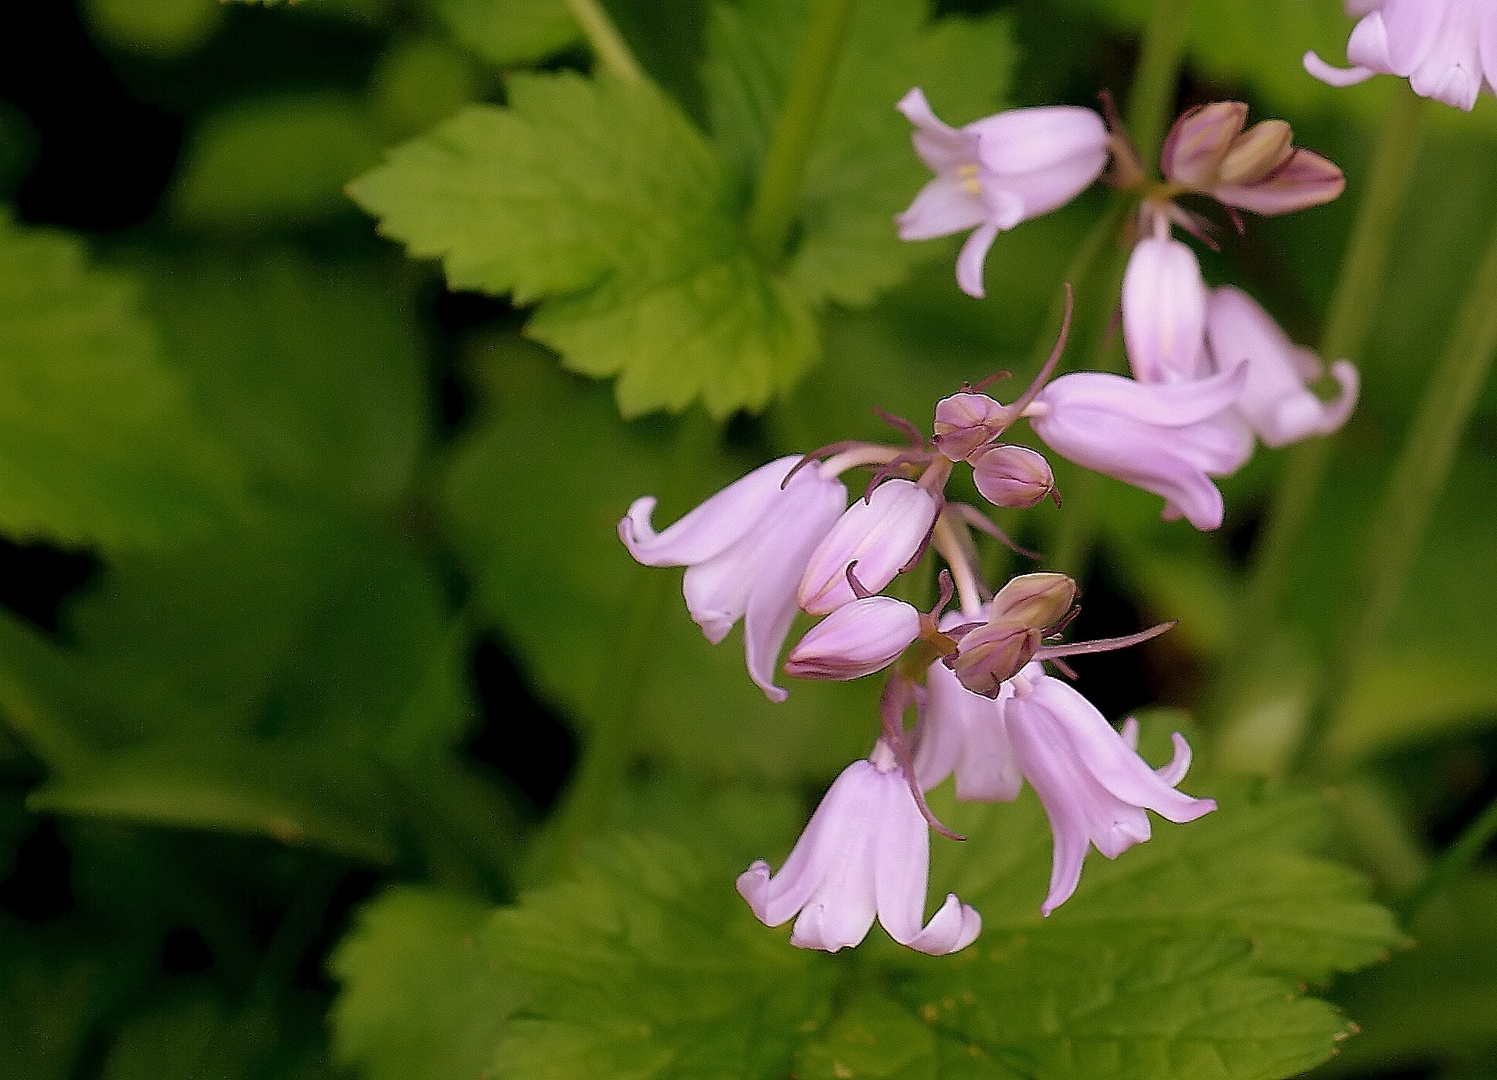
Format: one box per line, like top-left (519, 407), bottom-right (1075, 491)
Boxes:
top-left (1125, 234), bottom-right (1210, 383)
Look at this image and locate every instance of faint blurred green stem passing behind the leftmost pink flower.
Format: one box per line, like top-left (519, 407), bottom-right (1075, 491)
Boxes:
top-left (527, 409), bottom-right (719, 881)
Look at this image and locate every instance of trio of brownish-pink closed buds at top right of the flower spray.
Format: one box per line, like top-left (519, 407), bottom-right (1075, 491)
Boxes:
top-left (1160, 102), bottom-right (1346, 214)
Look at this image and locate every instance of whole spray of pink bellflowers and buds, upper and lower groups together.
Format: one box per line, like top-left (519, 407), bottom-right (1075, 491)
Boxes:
top-left (620, 90), bottom-right (1356, 954)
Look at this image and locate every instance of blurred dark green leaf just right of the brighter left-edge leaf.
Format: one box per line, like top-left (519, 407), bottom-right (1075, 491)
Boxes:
top-left (147, 253), bottom-right (428, 508)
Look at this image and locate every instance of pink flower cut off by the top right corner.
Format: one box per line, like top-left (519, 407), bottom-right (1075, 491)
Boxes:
top-left (1304, 0), bottom-right (1497, 111)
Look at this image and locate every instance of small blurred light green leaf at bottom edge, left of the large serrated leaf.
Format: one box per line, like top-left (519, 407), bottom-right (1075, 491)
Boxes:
top-left (331, 888), bottom-right (524, 1080)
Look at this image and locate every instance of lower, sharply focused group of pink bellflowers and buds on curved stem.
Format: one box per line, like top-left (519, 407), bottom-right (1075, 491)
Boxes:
top-left (618, 295), bottom-right (1214, 953)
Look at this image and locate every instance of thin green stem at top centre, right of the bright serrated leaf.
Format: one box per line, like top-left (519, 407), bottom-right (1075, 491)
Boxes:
top-left (744, 0), bottom-right (856, 267)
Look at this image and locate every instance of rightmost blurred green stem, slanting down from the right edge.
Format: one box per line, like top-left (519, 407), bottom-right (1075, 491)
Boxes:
top-left (1295, 202), bottom-right (1497, 768)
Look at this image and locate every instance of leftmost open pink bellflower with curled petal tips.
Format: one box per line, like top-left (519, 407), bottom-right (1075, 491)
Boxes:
top-left (618, 455), bottom-right (847, 701)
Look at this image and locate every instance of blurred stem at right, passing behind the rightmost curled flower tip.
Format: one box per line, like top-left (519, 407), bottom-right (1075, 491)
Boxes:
top-left (1225, 87), bottom-right (1424, 685)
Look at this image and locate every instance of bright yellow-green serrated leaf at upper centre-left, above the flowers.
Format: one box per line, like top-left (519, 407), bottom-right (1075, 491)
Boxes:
top-left (350, 73), bottom-right (816, 418)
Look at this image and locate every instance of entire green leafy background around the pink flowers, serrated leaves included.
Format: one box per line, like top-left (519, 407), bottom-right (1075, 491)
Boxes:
top-left (0, 0), bottom-right (1497, 1080)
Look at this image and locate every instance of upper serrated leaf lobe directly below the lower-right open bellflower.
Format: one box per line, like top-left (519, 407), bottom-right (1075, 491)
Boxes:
top-left (931, 779), bottom-right (1401, 981)
